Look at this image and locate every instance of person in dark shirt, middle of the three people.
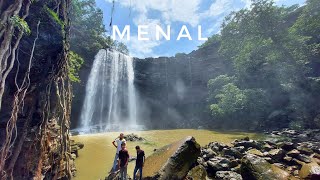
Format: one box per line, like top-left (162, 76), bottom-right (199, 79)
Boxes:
top-left (118, 142), bottom-right (129, 180)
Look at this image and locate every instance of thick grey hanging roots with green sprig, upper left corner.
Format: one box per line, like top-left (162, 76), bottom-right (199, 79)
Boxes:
top-left (0, 0), bottom-right (31, 111)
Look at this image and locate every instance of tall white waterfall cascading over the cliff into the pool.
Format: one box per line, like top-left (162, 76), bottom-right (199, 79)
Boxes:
top-left (80, 49), bottom-right (138, 132)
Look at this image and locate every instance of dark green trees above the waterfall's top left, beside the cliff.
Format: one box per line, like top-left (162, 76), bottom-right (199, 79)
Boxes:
top-left (70, 0), bottom-right (129, 74)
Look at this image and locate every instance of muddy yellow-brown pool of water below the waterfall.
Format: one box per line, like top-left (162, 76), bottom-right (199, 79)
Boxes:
top-left (72, 129), bottom-right (261, 180)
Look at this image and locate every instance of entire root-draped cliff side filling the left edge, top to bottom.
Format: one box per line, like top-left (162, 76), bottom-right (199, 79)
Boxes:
top-left (0, 0), bottom-right (73, 179)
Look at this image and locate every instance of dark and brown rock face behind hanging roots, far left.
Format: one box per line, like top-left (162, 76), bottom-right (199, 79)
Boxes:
top-left (0, 0), bottom-right (73, 179)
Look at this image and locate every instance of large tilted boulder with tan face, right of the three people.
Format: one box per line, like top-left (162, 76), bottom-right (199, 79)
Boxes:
top-left (143, 136), bottom-right (200, 180)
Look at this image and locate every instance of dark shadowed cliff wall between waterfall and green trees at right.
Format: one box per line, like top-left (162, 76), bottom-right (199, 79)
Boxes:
top-left (135, 44), bottom-right (229, 128)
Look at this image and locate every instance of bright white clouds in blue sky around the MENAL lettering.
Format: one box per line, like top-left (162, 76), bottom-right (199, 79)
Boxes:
top-left (105, 0), bottom-right (260, 57)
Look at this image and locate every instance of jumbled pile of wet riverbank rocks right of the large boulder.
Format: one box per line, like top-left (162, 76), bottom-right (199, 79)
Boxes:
top-left (197, 129), bottom-right (320, 180)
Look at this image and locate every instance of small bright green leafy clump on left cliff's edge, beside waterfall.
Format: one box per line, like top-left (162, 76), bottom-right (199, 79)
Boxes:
top-left (68, 51), bottom-right (84, 83)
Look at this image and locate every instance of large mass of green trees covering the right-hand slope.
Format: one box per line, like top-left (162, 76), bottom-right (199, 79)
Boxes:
top-left (205, 0), bottom-right (320, 128)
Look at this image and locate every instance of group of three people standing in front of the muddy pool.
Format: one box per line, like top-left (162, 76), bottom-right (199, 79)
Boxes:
top-left (112, 133), bottom-right (145, 180)
